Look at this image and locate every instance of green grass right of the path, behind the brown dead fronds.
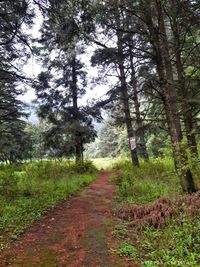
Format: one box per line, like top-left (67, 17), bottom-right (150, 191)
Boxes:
top-left (114, 159), bottom-right (179, 204)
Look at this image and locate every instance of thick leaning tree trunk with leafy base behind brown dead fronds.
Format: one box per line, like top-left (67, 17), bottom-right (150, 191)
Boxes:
top-left (157, 1), bottom-right (196, 193)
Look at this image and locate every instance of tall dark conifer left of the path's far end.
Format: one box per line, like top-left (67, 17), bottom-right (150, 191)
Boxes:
top-left (36, 1), bottom-right (100, 162)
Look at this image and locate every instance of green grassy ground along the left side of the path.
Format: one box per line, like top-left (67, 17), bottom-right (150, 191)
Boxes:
top-left (0, 161), bottom-right (97, 250)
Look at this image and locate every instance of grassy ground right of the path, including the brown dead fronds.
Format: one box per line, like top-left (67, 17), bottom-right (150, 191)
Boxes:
top-left (111, 159), bottom-right (200, 267)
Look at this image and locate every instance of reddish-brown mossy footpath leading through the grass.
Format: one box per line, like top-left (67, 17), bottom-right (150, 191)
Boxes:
top-left (0, 172), bottom-right (136, 267)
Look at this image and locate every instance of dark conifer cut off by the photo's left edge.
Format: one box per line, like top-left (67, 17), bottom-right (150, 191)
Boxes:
top-left (0, 0), bottom-right (33, 162)
